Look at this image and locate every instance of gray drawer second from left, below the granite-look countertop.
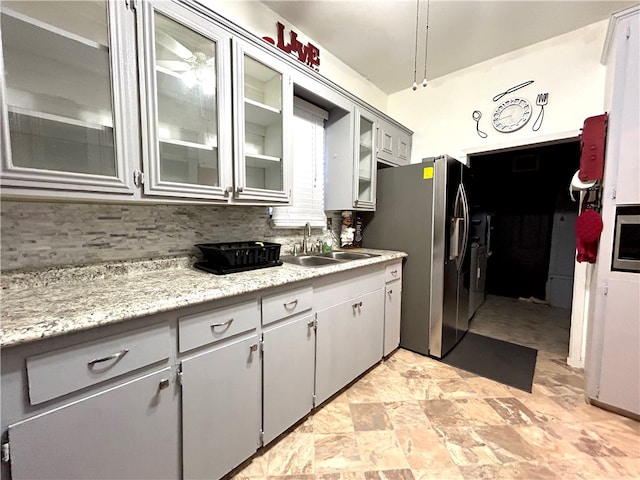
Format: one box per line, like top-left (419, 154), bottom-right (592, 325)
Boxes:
top-left (178, 300), bottom-right (260, 352)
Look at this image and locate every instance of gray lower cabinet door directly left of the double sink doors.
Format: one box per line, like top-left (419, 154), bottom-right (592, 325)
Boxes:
top-left (263, 315), bottom-right (315, 444)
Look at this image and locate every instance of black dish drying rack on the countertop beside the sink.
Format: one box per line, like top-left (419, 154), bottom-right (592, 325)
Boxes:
top-left (194, 241), bottom-right (282, 275)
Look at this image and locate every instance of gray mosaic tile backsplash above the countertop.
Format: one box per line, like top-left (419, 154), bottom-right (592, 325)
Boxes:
top-left (0, 201), bottom-right (321, 272)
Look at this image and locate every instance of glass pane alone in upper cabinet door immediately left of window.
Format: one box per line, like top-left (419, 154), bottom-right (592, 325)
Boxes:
top-left (244, 55), bottom-right (283, 191)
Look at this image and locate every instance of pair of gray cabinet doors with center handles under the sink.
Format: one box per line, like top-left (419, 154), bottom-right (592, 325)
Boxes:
top-left (316, 289), bottom-right (384, 405)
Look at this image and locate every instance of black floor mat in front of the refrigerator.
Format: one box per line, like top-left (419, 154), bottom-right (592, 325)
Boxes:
top-left (442, 332), bottom-right (538, 393)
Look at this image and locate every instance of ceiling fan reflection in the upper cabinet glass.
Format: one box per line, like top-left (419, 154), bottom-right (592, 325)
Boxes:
top-left (156, 30), bottom-right (216, 95)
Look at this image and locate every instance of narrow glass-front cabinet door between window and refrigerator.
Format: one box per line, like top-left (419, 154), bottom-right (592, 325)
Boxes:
top-left (353, 108), bottom-right (376, 210)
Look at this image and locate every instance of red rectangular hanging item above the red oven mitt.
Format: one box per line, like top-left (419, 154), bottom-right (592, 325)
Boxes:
top-left (578, 113), bottom-right (609, 182)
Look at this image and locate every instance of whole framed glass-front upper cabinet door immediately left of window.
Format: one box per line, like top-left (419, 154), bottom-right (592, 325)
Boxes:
top-left (234, 42), bottom-right (293, 203)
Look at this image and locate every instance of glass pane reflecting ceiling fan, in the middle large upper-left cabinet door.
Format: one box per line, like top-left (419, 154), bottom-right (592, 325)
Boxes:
top-left (154, 12), bottom-right (220, 186)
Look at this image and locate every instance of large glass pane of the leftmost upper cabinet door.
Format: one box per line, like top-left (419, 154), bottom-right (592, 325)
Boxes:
top-left (0, 1), bottom-right (117, 176)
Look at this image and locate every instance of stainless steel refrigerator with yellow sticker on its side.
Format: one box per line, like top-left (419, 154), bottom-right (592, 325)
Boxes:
top-left (363, 155), bottom-right (471, 358)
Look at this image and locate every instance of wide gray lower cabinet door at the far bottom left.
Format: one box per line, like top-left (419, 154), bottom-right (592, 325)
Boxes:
top-left (8, 367), bottom-right (180, 480)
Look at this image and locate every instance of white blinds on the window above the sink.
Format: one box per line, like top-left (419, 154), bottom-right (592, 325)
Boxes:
top-left (271, 97), bottom-right (329, 228)
